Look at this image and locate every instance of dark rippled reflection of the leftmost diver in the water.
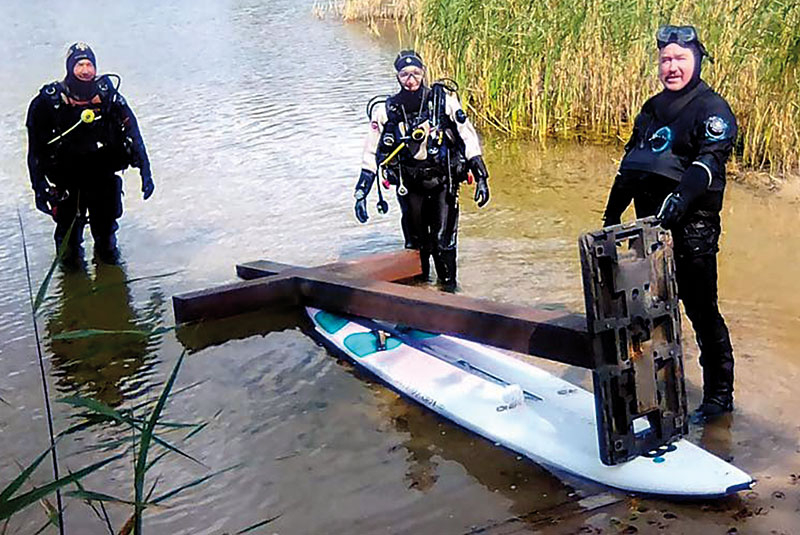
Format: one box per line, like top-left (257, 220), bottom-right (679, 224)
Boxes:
top-left (47, 260), bottom-right (164, 406)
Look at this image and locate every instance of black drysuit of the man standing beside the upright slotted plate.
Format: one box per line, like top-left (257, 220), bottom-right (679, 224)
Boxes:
top-left (604, 80), bottom-right (737, 410)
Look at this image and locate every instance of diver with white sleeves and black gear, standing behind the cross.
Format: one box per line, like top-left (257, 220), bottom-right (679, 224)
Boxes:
top-left (355, 50), bottom-right (489, 291)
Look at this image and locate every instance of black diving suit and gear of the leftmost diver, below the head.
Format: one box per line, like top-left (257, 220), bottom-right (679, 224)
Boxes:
top-left (26, 76), bottom-right (150, 255)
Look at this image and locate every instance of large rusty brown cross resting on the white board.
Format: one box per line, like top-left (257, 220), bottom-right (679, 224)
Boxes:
top-left (173, 250), bottom-right (594, 368)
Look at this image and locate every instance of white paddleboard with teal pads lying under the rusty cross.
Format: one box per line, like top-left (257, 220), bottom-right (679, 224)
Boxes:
top-left (306, 307), bottom-right (753, 498)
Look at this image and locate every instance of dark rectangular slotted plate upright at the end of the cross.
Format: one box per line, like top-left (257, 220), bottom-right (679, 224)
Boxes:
top-left (579, 218), bottom-right (688, 465)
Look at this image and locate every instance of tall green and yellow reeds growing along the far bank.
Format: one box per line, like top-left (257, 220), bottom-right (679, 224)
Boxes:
top-left (342, 0), bottom-right (800, 180)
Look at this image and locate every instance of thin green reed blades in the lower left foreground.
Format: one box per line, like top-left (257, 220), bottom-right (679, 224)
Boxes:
top-left (5, 212), bottom-right (280, 535)
